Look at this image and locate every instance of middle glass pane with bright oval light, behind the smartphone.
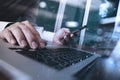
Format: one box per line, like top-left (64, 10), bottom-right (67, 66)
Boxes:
top-left (61, 0), bottom-right (87, 47)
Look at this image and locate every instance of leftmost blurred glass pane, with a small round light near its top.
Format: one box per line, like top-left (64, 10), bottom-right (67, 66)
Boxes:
top-left (37, 0), bottom-right (59, 31)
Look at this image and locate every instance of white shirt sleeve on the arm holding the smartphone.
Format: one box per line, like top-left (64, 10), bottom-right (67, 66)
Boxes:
top-left (35, 27), bottom-right (55, 42)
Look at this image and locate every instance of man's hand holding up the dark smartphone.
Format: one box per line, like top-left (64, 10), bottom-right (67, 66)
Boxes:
top-left (53, 28), bottom-right (74, 45)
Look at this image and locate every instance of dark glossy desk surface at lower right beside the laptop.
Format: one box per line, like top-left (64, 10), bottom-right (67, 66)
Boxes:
top-left (75, 57), bottom-right (120, 80)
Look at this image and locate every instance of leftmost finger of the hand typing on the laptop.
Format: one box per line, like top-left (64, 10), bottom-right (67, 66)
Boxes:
top-left (1, 29), bottom-right (16, 44)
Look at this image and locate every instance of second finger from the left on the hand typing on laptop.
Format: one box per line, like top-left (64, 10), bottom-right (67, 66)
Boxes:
top-left (10, 23), bottom-right (27, 47)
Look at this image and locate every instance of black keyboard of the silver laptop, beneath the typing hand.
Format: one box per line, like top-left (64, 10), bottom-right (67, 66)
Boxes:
top-left (10, 48), bottom-right (93, 70)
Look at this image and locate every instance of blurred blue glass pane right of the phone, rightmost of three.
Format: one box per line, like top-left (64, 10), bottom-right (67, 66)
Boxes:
top-left (82, 0), bottom-right (119, 54)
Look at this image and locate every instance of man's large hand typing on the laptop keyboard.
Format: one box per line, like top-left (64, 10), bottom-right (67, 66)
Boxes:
top-left (0, 21), bottom-right (46, 49)
